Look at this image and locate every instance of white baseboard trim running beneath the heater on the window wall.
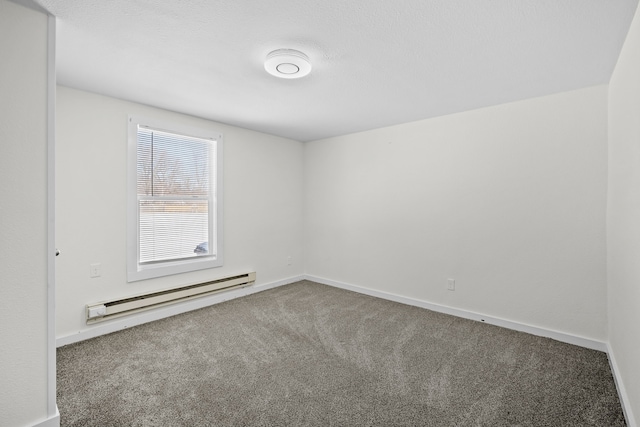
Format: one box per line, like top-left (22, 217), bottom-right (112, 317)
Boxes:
top-left (56, 275), bottom-right (304, 347)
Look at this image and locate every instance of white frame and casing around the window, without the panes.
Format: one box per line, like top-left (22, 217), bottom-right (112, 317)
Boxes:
top-left (127, 116), bottom-right (224, 282)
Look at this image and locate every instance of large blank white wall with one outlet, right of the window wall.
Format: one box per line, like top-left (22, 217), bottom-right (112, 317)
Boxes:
top-left (304, 86), bottom-right (607, 341)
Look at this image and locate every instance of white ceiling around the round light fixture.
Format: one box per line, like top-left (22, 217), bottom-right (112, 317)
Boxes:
top-left (36, 0), bottom-right (638, 141)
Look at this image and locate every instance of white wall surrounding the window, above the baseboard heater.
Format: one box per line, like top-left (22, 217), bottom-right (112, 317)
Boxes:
top-left (56, 87), bottom-right (303, 337)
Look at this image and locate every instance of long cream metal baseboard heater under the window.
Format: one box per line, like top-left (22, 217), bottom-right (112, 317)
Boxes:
top-left (86, 272), bottom-right (256, 324)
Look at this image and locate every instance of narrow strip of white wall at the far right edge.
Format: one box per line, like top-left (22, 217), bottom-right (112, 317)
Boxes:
top-left (607, 0), bottom-right (640, 425)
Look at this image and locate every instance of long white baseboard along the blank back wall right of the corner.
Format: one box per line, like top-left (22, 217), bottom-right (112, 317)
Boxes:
top-left (304, 274), bottom-right (607, 352)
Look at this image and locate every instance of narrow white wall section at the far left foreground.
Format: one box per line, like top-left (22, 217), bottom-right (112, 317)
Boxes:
top-left (0, 0), bottom-right (48, 426)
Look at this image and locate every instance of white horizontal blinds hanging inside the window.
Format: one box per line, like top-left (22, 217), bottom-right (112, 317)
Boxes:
top-left (136, 125), bottom-right (216, 264)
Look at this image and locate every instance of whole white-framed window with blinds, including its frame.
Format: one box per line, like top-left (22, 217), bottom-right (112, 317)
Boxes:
top-left (127, 117), bottom-right (222, 282)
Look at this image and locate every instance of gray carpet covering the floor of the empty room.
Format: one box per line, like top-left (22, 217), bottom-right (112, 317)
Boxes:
top-left (58, 281), bottom-right (625, 426)
